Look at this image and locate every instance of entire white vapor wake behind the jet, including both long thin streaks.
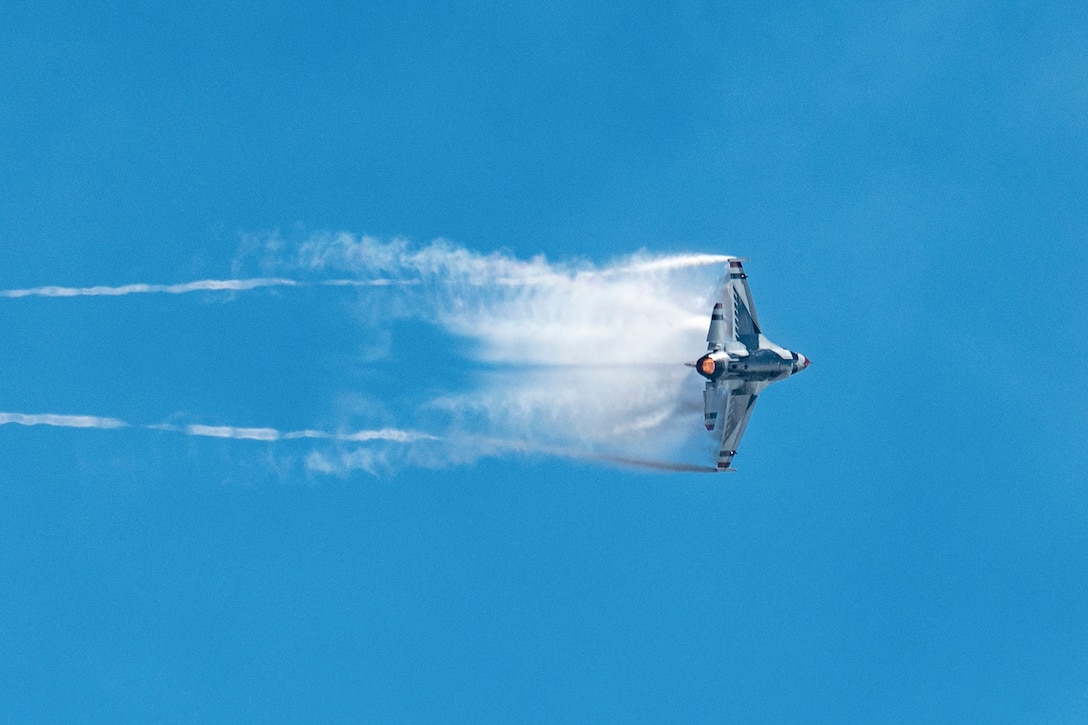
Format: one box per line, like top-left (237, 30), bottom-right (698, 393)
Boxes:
top-left (0, 233), bottom-right (733, 475)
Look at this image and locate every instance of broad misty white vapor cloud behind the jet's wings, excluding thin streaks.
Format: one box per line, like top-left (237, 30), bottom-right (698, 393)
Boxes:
top-left (249, 228), bottom-right (733, 471)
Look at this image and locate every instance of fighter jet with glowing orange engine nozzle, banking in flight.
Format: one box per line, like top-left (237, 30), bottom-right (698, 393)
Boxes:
top-left (689, 259), bottom-right (812, 470)
